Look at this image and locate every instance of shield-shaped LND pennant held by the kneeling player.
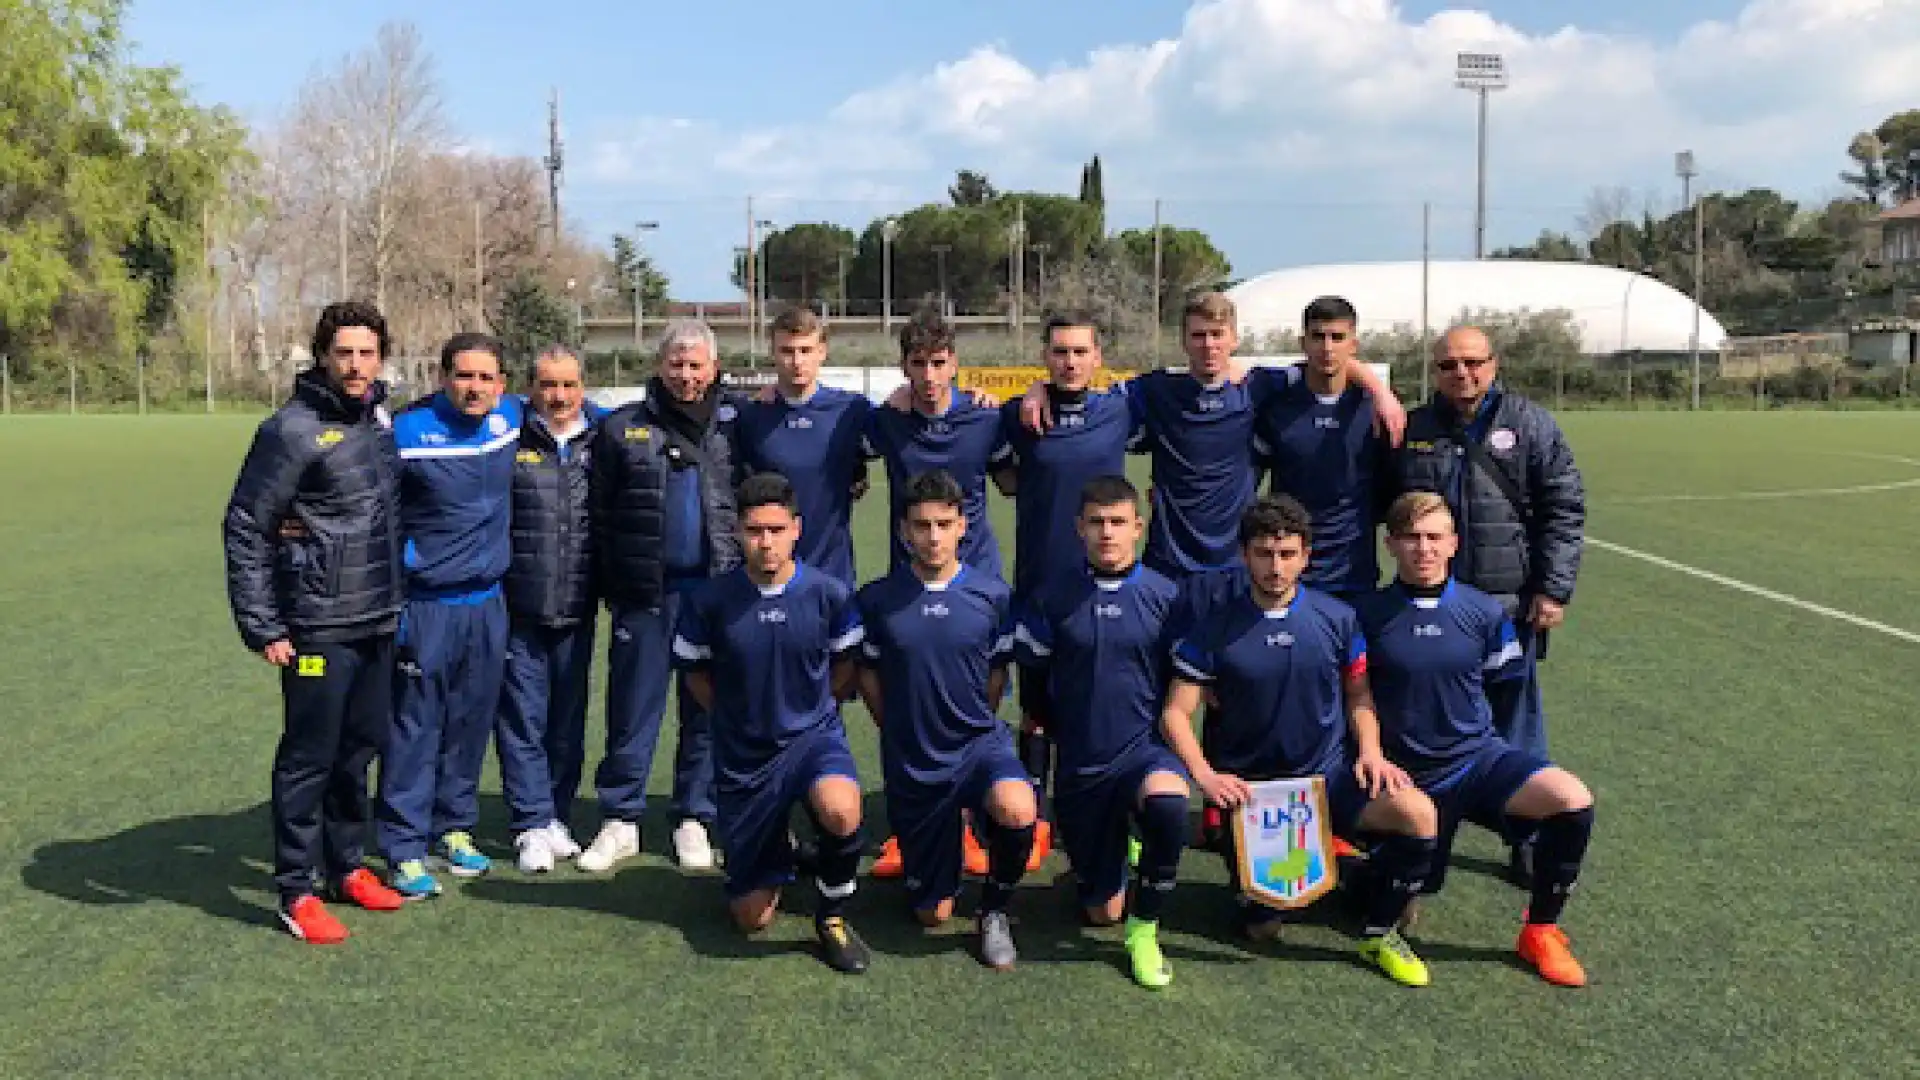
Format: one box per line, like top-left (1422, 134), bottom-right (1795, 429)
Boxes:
top-left (1233, 776), bottom-right (1340, 911)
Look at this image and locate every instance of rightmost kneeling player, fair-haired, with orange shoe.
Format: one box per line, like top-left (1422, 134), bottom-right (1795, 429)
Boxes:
top-left (1359, 492), bottom-right (1594, 986)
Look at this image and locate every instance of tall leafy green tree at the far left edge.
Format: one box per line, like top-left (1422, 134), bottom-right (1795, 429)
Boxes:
top-left (0, 0), bottom-right (242, 356)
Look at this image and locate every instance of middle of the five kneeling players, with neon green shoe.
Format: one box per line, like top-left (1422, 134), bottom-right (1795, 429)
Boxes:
top-left (1014, 475), bottom-right (1188, 990)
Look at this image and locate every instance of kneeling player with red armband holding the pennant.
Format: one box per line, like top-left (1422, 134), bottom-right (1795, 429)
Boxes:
top-left (1162, 496), bottom-right (1438, 986)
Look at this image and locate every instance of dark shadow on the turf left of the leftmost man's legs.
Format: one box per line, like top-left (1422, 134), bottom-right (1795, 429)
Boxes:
top-left (19, 803), bottom-right (276, 926)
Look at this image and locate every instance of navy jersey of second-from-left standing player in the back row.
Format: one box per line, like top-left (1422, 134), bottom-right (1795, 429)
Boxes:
top-left (866, 390), bottom-right (1010, 577)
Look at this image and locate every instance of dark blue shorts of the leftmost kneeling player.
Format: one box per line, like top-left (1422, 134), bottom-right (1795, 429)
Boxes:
top-left (714, 724), bottom-right (860, 899)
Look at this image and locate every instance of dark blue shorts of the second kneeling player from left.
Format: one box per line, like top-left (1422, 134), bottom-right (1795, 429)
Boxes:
top-left (887, 728), bottom-right (1031, 911)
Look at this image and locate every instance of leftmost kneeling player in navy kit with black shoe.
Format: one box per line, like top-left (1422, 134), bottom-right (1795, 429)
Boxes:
top-left (674, 473), bottom-right (870, 974)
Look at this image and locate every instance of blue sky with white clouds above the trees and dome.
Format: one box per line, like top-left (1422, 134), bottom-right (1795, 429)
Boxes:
top-left (129, 0), bottom-right (1920, 300)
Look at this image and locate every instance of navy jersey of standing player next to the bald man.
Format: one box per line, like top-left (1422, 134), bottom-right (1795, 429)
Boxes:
top-left (1254, 380), bottom-right (1386, 596)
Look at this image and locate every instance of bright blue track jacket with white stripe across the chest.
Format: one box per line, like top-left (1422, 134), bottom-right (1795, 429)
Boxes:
top-left (394, 392), bottom-right (526, 600)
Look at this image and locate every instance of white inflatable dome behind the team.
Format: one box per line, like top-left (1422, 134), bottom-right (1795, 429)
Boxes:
top-left (1227, 259), bottom-right (1726, 354)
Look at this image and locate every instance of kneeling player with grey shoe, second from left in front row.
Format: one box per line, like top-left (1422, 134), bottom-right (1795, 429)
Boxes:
top-left (858, 473), bottom-right (1035, 969)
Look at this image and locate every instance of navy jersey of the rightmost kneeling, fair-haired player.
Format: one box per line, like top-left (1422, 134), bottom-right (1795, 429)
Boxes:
top-left (1359, 580), bottom-right (1521, 788)
